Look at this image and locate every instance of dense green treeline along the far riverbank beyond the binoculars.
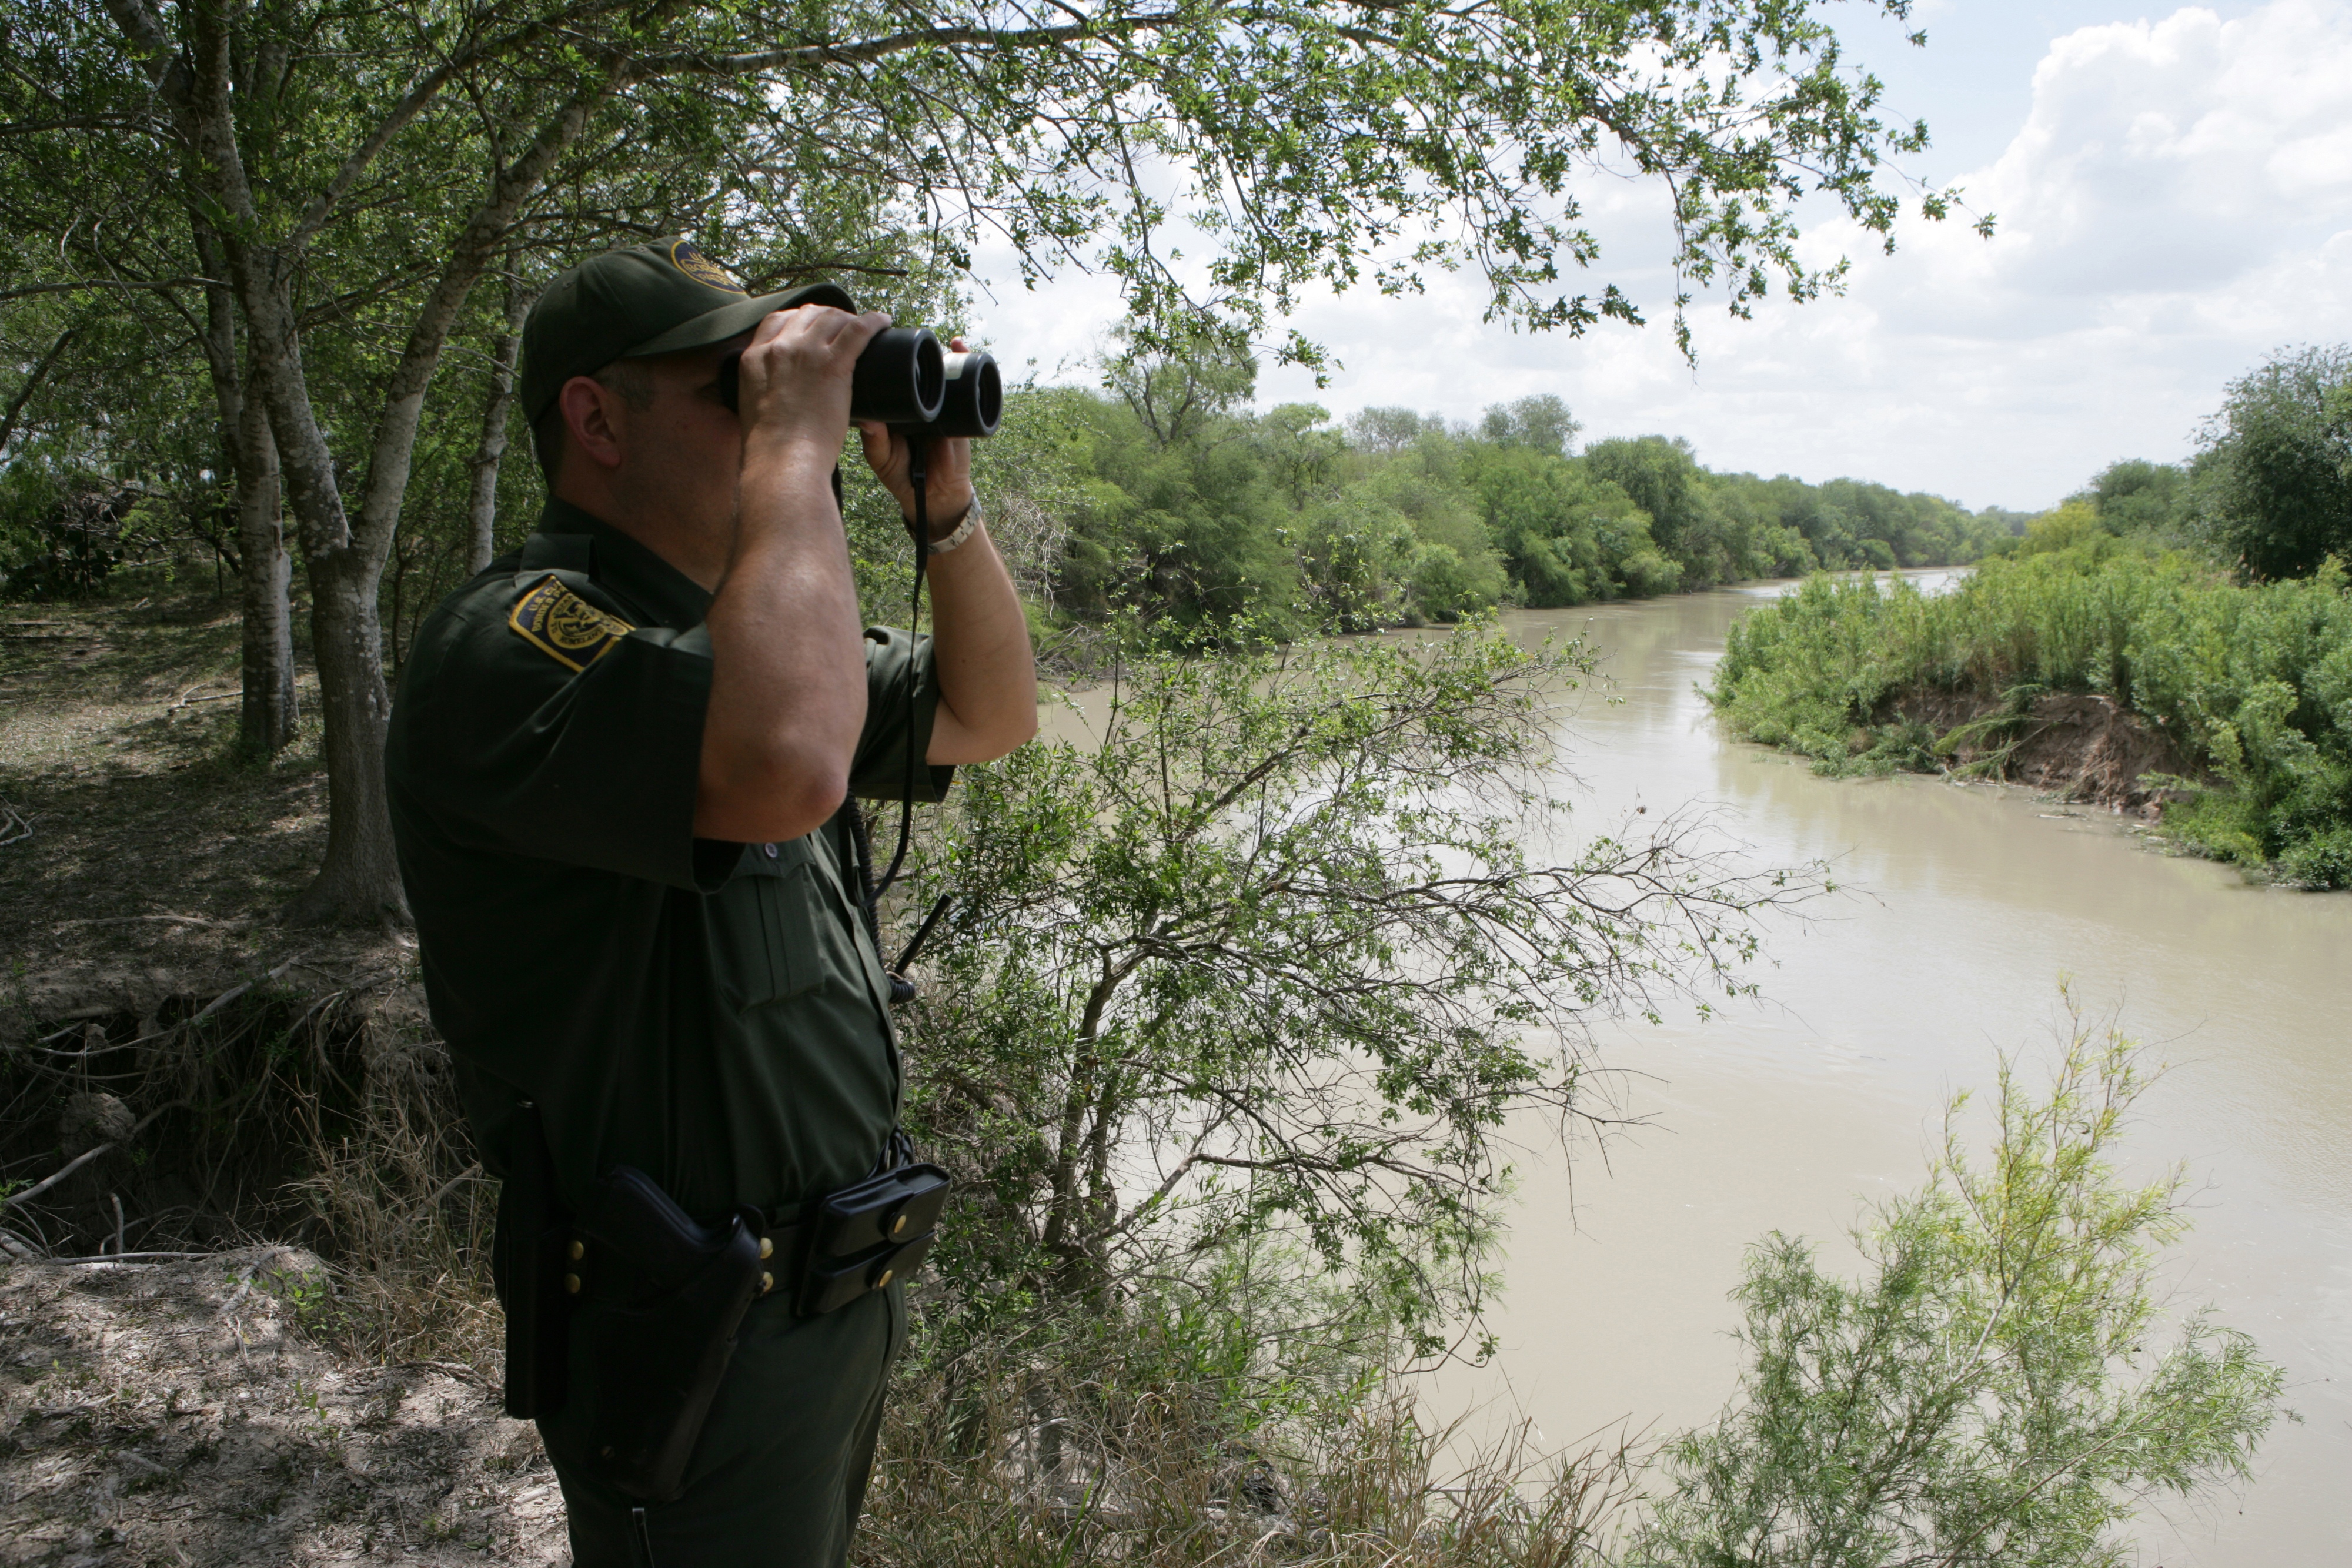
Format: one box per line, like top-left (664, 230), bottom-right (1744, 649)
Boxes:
top-left (983, 340), bottom-right (2009, 642)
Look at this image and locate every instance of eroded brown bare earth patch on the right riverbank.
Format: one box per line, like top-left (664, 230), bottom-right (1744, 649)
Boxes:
top-left (1893, 691), bottom-right (2197, 820)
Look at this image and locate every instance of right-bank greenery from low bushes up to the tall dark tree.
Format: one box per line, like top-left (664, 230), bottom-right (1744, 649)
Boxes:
top-left (1710, 346), bottom-right (2352, 888)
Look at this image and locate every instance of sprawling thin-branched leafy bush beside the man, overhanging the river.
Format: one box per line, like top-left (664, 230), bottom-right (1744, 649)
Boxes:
top-left (908, 628), bottom-right (1809, 1352)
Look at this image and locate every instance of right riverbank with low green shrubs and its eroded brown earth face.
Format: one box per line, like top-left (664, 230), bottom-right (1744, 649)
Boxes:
top-left (1708, 541), bottom-right (2352, 888)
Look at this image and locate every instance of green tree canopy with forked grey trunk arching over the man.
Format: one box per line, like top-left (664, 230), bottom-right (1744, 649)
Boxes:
top-left (0, 0), bottom-right (1950, 917)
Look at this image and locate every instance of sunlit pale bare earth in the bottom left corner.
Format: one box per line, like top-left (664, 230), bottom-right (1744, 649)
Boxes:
top-left (0, 1246), bottom-right (567, 1568)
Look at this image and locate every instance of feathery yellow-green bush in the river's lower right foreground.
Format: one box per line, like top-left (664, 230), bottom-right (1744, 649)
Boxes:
top-left (1628, 1015), bottom-right (2284, 1568)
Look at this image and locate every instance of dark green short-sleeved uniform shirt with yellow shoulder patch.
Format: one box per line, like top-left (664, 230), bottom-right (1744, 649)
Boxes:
top-left (386, 501), bottom-right (953, 1220)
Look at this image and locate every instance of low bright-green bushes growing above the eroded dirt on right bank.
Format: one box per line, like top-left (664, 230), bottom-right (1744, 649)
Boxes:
top-left (1708, 550), bottom-right (2352, 888)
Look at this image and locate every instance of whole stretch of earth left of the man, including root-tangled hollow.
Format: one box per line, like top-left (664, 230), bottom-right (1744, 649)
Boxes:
top-left (0, 593), bottom-right (567, 1568)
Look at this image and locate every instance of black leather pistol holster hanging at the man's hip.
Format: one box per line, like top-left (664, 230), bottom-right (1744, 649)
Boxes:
top-left (574, 1166), bottom-right (760, 1502)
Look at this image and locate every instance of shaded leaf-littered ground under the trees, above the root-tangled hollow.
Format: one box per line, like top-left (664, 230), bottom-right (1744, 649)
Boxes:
top-left (0, 593), bottom-right (397, 1039)
